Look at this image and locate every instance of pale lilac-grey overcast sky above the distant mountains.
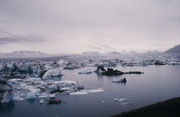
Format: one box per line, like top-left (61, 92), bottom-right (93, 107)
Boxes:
top-left (0, 0), bottom-right (180, 54)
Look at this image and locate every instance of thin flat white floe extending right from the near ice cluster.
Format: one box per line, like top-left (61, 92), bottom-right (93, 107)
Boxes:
top-left (70, 88), bottom-right (104, 95)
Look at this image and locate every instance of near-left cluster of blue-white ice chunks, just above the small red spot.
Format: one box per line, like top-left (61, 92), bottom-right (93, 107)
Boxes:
top-left (1, 78), bottom-right (81, 103)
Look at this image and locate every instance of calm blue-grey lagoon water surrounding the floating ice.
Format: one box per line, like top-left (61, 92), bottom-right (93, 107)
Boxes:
top-left (0, 65), bottom-right (180, 117)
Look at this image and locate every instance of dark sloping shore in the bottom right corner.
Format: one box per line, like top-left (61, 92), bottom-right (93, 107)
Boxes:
top-left (112, 97), bottom-right (180, 117)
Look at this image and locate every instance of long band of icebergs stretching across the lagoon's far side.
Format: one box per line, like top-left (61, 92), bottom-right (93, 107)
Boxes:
top-left (0, 54), bottom-right (180, 79)
